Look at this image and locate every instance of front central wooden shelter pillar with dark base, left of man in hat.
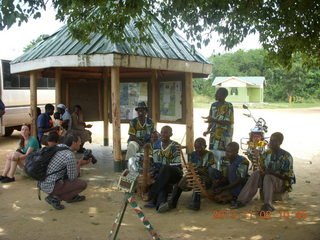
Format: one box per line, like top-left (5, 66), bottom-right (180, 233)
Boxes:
top-left (111, 67), bottom-right (124, 172)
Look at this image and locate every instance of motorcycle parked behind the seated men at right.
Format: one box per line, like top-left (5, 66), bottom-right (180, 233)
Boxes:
top-left (240, 104), bottom-right (268, 171)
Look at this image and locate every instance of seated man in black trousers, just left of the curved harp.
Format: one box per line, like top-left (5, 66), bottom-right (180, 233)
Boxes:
top-left (145, 126), bottom-right (183, 213)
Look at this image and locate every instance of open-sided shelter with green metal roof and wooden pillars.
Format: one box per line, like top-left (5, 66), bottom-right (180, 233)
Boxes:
top-left (11, 19), bottom-right (212, 171)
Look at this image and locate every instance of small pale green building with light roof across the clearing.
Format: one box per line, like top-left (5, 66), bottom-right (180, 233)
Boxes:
top-left (212, 76), bottom-right (265, 103)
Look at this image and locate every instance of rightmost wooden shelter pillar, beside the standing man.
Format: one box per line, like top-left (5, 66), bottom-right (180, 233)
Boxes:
top-left (185, 73), bottom-right (194, 153)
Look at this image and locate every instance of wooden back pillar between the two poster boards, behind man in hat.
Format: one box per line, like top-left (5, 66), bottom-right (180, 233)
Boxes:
top-left (149, 70), bottom-right (160, 128)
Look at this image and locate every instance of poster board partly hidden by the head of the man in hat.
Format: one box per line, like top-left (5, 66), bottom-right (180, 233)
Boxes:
top-left (120, 82), bottom-right (148, 120)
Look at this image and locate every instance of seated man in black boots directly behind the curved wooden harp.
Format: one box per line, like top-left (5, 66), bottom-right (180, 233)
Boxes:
top-left (185, 138), bottom-right (215, 210)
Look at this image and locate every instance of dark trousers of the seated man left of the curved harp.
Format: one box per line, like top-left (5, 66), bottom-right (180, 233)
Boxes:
top-left (150, 165), bottom-right (182, 206)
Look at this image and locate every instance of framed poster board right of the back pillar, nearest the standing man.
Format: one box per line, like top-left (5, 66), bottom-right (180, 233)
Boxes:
top-left (160, 81), bottom-right (182, 121)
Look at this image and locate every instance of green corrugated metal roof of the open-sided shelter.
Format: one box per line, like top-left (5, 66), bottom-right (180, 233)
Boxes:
top-left (11, 19), bottom-right (210, 64)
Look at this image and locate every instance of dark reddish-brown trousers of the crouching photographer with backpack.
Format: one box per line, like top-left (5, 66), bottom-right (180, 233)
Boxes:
top-left (51, 179), bottom-right (87, 201)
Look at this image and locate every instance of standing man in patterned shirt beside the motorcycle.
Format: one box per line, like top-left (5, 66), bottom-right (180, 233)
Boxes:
top-left (203, 88), bottom-right (234, 169)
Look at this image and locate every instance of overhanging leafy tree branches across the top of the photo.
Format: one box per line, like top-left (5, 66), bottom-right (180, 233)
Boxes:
top-left (0, 0), bottom-right (320, 68)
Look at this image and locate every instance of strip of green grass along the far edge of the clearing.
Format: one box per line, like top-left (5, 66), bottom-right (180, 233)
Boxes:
top-left (193, 94), bottom-right (320, 109)
